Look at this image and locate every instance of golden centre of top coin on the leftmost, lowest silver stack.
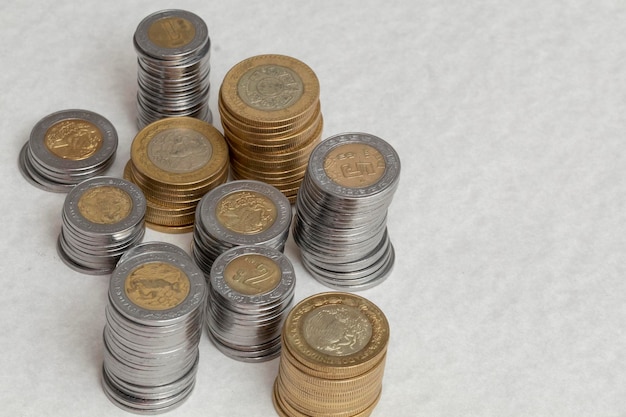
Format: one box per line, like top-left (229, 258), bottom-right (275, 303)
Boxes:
top-left (44, 119), bottom-right (103, 161)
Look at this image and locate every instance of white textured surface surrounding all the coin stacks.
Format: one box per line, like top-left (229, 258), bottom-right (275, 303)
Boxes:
top-left (0, 0), bottom-right (626, 417)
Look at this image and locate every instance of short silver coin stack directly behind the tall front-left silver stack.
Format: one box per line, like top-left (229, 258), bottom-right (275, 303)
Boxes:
top-left (57, 177), bottom-right (146, 275)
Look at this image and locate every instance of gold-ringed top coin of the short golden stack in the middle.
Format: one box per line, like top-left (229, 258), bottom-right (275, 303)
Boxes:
top-left (131, 117), bottom-right (228, 185)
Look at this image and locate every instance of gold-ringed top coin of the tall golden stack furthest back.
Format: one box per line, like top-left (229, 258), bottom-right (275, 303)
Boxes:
top-left (220, 54), bottom-right (320, 126)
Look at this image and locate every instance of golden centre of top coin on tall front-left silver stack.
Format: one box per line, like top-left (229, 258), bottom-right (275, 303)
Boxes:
top-left (124, 262), bottom-right (190, 311)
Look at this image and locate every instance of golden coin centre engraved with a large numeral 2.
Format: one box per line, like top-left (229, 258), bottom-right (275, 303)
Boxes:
top-left (224, 254), bottom-right (282, 295)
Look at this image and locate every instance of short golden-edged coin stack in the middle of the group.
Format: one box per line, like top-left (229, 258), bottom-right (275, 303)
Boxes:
top-left (124, 117), bottom-right (228, 233)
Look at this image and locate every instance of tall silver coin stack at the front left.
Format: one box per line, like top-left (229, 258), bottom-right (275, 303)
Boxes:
top-left (102, 249), bottom-right (207, 414)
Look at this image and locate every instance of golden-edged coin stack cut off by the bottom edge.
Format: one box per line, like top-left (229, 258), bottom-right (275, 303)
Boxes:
top-left (273, 293), bottom-right (389, 417)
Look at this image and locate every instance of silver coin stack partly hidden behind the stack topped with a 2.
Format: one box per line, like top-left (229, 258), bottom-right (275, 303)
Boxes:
top-left (192, 180), bottom-right (291, 276)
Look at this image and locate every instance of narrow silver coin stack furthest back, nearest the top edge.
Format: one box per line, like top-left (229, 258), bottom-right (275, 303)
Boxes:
top-left (133, 10), bottom-right (213, 129)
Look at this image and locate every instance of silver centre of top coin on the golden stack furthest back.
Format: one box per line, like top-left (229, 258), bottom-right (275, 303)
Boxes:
top-left (237, 64), bottom-right (304, 111)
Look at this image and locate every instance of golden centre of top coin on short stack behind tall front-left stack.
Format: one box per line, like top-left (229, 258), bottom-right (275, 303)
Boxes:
top-left (77, 185), bottom-right (133, 224)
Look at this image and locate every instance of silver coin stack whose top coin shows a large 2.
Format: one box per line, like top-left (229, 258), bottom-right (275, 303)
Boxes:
top-left (206, 246), bottom-right (295, 362)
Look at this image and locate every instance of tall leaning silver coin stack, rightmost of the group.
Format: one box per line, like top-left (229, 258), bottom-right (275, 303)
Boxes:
top-left (293, 133), bottom-right (400, 291)
